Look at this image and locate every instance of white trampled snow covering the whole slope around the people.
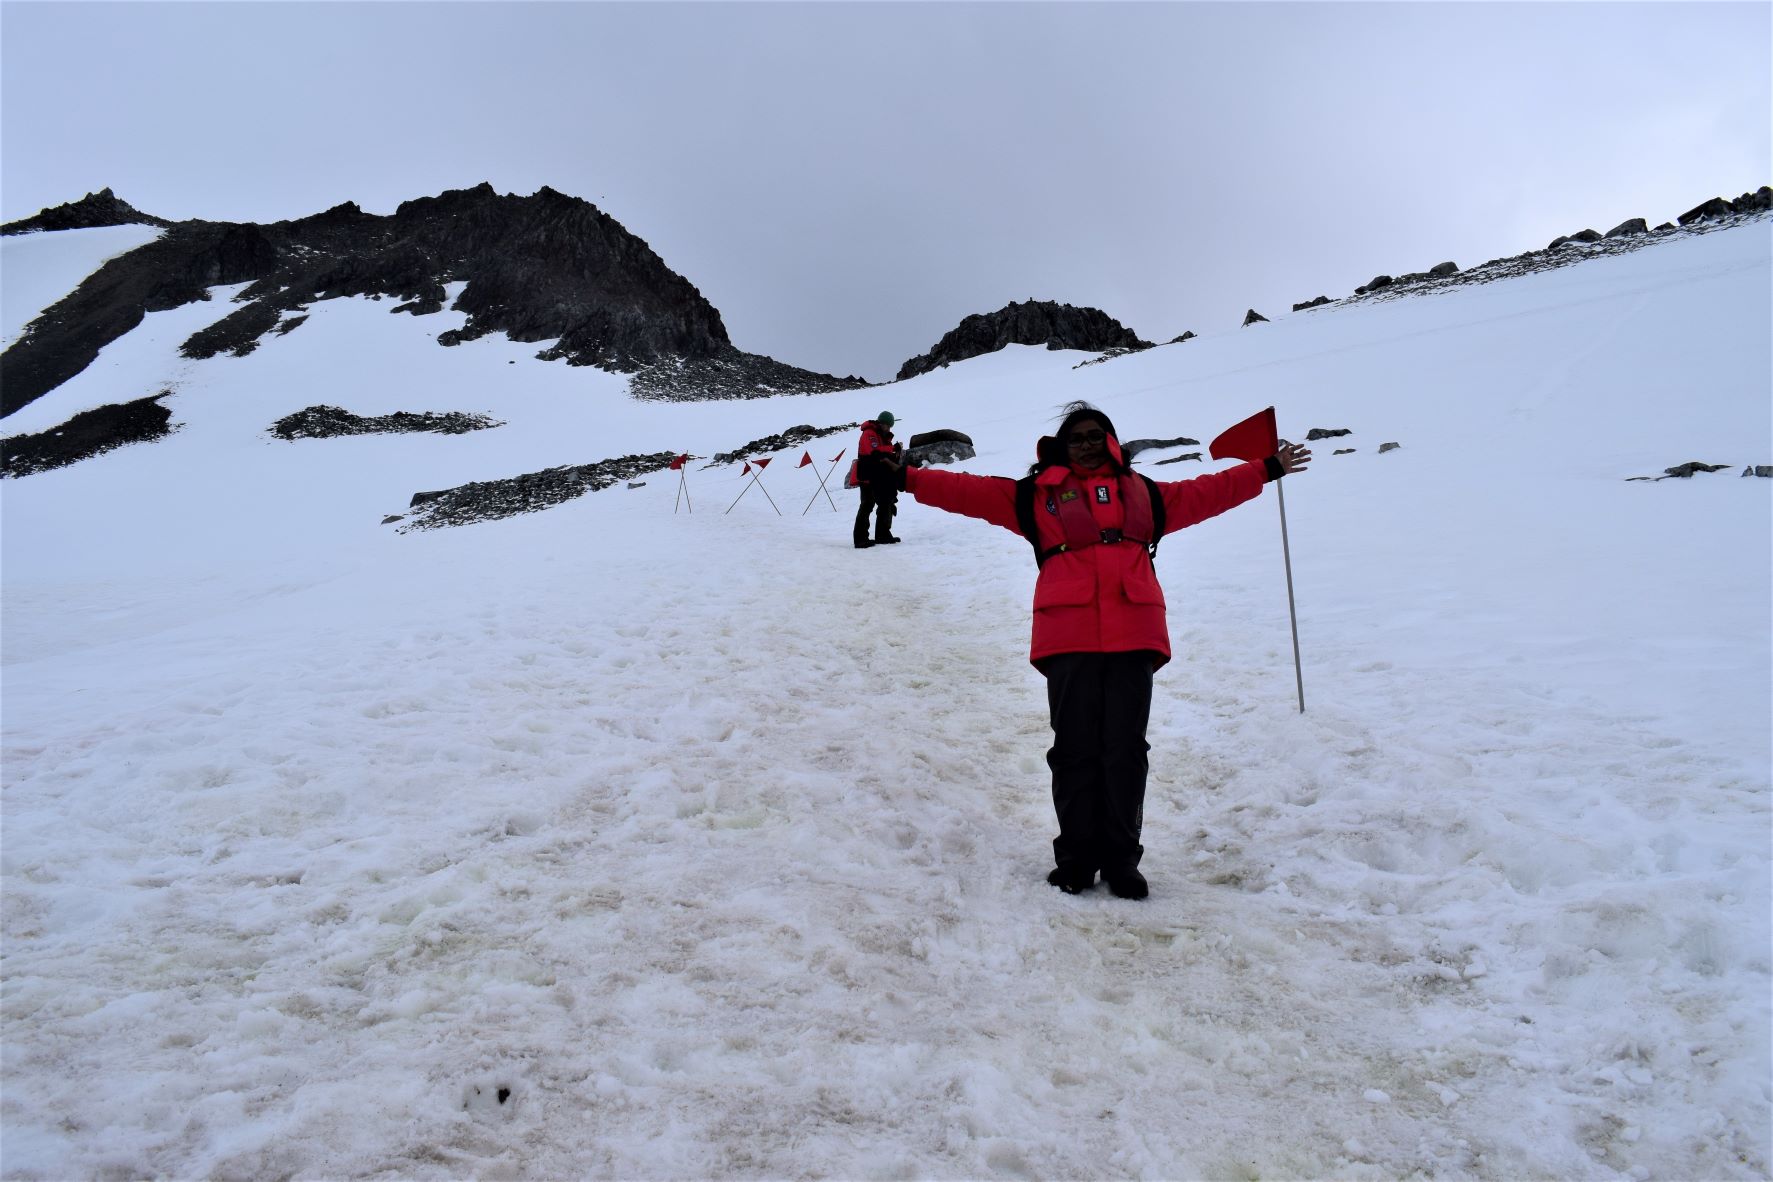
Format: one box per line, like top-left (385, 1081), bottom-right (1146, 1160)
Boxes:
top-left (0, 222), bottom-right (1773, 1178)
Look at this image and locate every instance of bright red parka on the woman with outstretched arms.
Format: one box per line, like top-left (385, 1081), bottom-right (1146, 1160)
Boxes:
top-left (904, 463), bottom-right (1268, 666)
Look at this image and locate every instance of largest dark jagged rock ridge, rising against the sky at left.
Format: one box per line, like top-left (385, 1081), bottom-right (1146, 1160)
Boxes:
top-left (0, 184), bottom-right (867, 415)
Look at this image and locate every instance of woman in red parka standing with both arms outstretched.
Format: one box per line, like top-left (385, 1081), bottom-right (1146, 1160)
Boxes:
top-left (904, 402), bottom-right (1312, 898)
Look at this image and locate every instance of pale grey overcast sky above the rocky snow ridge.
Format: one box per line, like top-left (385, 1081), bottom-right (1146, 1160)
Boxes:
top-left (0, 2), bottom-right (1773, 381)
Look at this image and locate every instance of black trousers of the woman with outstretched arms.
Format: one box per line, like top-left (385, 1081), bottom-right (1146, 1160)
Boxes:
top-left (1039, 652), bottom-right (1156, 875)
